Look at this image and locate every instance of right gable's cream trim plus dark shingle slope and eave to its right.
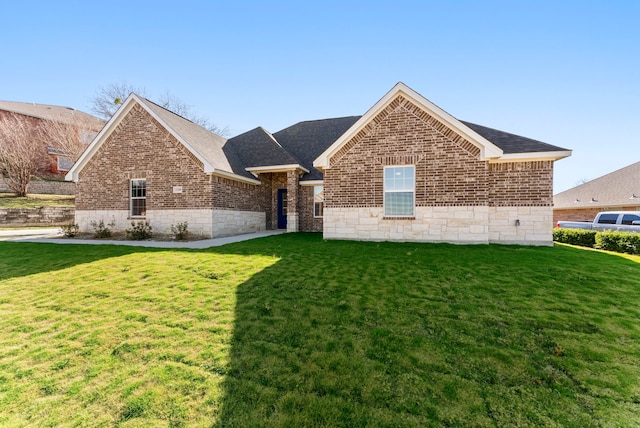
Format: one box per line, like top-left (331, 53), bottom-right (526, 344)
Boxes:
top-left (313, 82), bottom-right (571, 169)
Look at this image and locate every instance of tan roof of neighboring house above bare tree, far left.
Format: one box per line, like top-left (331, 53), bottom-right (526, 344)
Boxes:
top-left (0, 101), bottom-right (104, 131)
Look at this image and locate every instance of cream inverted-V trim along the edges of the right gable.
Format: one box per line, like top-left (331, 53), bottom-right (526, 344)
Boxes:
top-left (313, 82), bottom-right (503, 168)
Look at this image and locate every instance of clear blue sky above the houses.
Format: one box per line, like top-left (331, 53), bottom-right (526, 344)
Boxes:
top-left (0, 0), bottom-right (640, 192)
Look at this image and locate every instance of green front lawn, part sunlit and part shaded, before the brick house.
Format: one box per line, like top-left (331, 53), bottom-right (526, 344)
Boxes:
top-left (0, 234), bottom-right (640, 427)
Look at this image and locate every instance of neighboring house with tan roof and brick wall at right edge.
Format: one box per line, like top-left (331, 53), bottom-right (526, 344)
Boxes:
top-left (553, 162), bottom-right (640, 224)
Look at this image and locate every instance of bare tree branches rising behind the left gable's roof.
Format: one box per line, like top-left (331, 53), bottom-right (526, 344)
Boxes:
top-left (91, 82), bottom-right (229, 136)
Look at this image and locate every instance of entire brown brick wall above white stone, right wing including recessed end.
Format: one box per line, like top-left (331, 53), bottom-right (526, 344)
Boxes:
top-left (324, 96), bottom-right (553, 208)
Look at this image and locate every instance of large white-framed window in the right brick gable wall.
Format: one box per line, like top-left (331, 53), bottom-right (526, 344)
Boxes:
top-left (384, 165), bottom-right (415, 217)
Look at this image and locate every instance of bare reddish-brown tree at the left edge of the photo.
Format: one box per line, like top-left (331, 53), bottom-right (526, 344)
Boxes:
top-left (0, 114), bottom-right (49, 196)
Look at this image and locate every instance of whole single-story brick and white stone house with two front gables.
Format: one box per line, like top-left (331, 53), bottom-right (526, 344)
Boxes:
top-left (67, 83), bottom-right (571, 245)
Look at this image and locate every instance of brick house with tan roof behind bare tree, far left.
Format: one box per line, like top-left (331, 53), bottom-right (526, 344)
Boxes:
top-left (0, 101), bottom-right (104, 179)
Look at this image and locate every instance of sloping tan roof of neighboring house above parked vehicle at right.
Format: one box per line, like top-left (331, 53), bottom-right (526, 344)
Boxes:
top-left (553, 162), bottom-right (640, 209)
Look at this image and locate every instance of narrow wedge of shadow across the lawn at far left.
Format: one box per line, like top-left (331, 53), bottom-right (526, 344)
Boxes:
top-left (0, 242), bottom-right (161, 280)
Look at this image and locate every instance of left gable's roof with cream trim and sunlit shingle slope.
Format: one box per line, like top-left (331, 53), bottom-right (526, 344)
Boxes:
top-left (65, 93), bottom-right (259, 184)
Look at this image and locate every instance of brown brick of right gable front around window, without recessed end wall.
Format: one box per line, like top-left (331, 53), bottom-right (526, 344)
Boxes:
top-left (324, 97), bottom-right (488, 208)
